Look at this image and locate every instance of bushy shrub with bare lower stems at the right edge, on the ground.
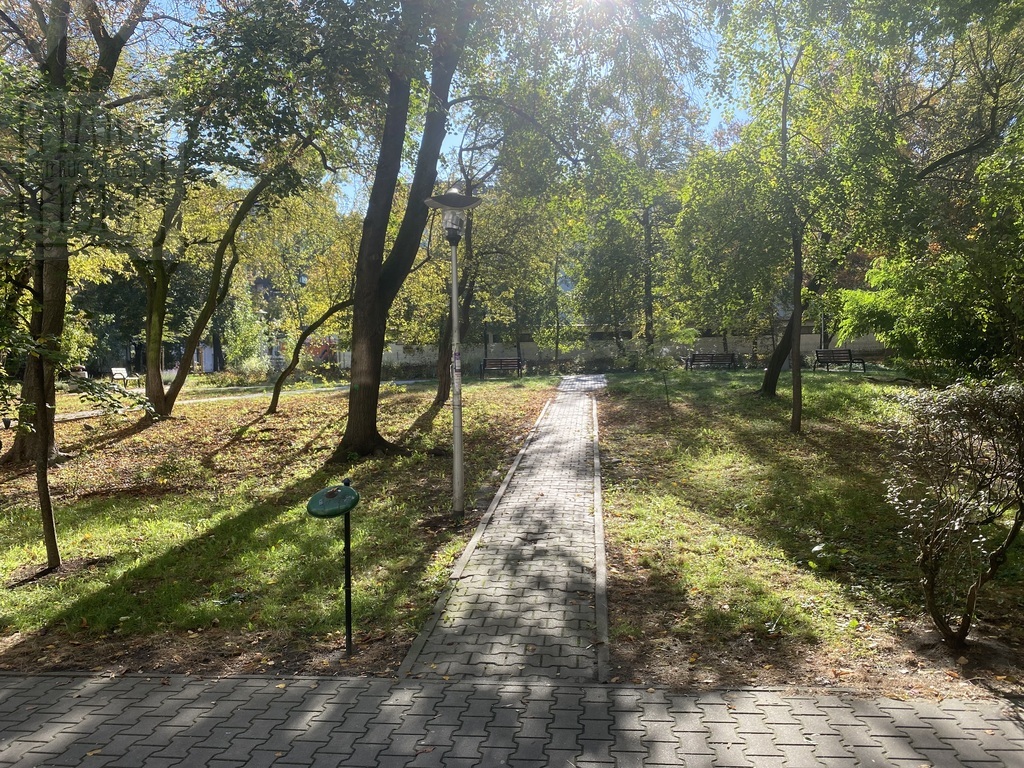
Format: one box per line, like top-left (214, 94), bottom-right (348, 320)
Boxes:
top-left (889, 381), bottom-right (1024, 647)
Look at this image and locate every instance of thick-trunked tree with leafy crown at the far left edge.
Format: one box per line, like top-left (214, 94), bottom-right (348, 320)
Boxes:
top-left (0, 0), bottom-right (159, 461)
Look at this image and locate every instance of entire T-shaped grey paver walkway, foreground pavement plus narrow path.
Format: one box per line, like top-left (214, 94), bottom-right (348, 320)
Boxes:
top-left (0, 378), bottom-right (1024, 768)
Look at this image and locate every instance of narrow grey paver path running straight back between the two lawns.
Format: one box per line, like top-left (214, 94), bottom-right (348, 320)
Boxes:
top-left (398, 376), bottom-right (607, 682)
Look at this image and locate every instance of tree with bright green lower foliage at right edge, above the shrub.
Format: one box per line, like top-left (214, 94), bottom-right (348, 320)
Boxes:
top-left (841, 8), bottom-right (1024, 376)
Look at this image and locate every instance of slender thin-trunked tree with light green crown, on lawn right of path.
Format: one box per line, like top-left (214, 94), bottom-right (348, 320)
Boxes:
top-left (720, 2), bottom-right (921, 432)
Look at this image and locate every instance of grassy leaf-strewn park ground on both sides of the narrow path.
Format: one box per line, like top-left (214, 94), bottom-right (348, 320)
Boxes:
top-left (0, 371), bottom-right (1024, 698)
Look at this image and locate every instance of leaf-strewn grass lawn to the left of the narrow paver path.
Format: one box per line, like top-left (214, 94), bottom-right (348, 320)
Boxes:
top-left (0, 379), bottom-right (553, 674)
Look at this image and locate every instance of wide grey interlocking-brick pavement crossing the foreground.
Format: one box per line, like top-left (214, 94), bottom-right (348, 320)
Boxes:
top-left (0, 675), bottom-right (1024, 768)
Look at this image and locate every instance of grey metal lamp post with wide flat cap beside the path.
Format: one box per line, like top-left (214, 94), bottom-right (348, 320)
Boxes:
top-left (423, 186), bottom-right (483, 519)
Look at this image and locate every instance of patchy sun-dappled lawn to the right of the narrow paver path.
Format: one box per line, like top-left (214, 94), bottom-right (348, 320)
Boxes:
top-left (600, 372), bottom-right (1024, 695)
